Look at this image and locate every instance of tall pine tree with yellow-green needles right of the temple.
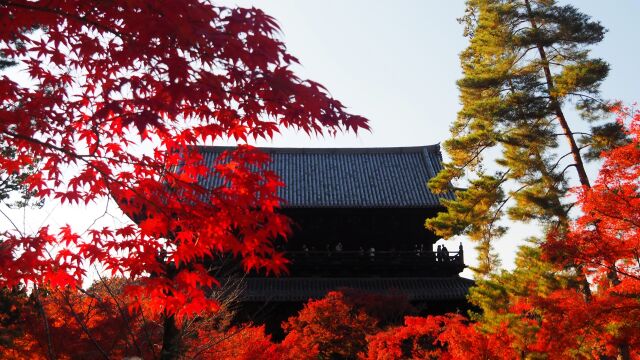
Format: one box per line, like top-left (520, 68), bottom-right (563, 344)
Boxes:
top-left (426, 0), bottom-right (625, 277)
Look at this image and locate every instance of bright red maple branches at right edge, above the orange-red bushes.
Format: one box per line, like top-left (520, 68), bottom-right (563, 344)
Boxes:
top-left (547, 109), bottom-right (640, 286)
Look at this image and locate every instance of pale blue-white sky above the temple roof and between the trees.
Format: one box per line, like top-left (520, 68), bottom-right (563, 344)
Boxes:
top-left (0, 0), bottom-right (640, 275)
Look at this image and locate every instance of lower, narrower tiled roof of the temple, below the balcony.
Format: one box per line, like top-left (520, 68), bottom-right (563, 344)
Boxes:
top-left (241, 277), bottom-right (474, 302)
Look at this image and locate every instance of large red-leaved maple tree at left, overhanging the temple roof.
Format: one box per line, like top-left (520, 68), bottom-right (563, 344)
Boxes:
top-left (0, 0), bottom-right (368, 358)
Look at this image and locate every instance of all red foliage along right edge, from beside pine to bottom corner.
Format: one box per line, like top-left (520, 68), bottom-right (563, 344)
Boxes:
top-left (543, 105), bottom-right (640, 356)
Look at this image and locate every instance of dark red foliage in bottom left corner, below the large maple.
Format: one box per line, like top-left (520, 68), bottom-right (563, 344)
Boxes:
top-left (0, 279), bottom-right (155, 359)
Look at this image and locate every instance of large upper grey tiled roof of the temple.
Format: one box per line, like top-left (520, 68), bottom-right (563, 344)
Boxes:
top-left (199, 145), bottom-right (452, 208)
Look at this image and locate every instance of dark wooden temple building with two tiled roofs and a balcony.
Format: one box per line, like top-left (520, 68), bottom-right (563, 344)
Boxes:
top-left (200, 145), bottom-right (473, 333)
